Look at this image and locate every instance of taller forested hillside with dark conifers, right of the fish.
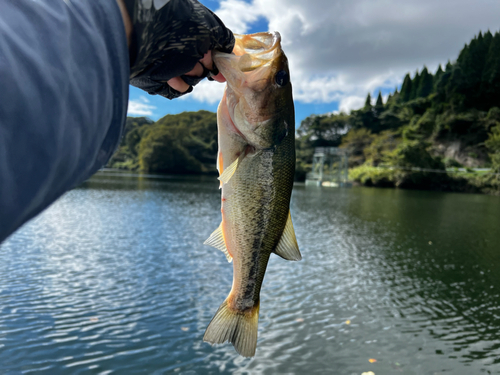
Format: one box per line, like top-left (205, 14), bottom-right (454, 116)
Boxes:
top-left (297, 31), bottom-right (500, 193)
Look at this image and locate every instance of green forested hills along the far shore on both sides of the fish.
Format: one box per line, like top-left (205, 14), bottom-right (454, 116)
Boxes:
top-left (108, 31), bottom-right (500, 194)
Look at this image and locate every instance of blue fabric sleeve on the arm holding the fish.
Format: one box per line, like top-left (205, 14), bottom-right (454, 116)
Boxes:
top-left (0, 0), bottom-right (130, 242)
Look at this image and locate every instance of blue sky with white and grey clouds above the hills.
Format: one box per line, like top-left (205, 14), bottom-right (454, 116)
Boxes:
top-left (128, 0), bottom-right (500, 127)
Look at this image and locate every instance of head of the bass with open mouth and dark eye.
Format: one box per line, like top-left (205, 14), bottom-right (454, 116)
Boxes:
top-left (214, 32), bottom-right (295, 149)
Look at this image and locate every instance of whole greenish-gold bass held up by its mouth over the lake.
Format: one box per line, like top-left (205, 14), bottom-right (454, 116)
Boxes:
top-left (203, 32), bottom-right (302, 357)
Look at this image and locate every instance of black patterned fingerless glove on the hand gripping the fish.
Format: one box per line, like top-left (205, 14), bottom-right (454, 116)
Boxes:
top-left (125, 0), bottom-right (234, 99)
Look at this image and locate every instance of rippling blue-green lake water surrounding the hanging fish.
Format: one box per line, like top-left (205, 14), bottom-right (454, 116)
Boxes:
top-left (0, 172), bottom-right (500, 375)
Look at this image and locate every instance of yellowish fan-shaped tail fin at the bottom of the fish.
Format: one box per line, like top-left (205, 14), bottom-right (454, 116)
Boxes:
top-left (203, 300), bottom-right (259, 357)
